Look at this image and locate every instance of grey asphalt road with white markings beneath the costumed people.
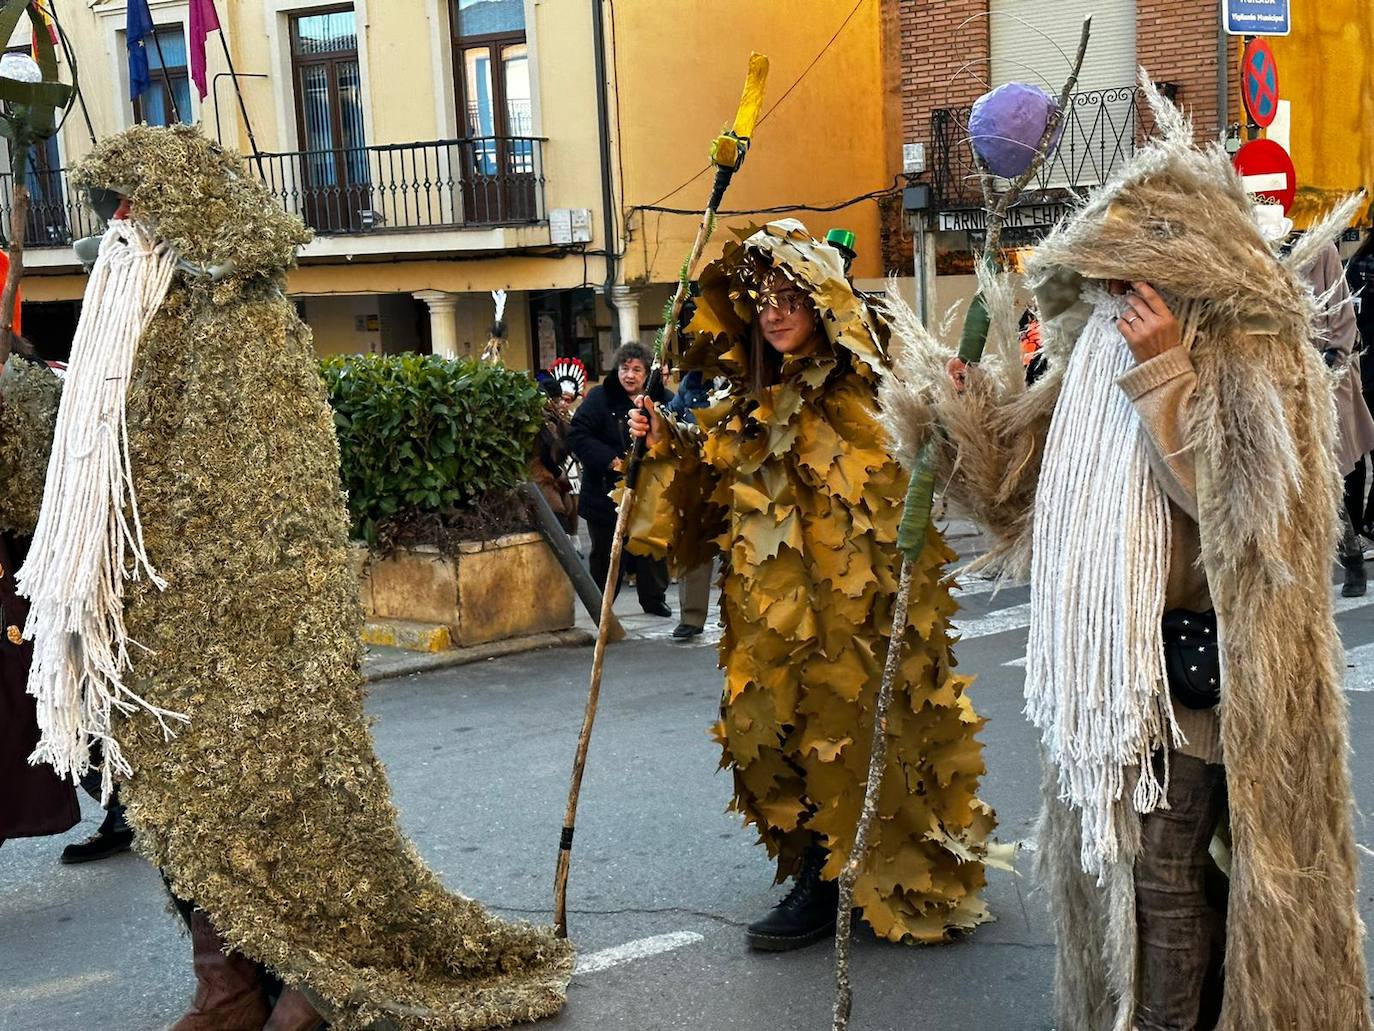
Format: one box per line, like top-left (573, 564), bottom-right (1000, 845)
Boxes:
top-left (0, 574), bottom-right (1374, 1031)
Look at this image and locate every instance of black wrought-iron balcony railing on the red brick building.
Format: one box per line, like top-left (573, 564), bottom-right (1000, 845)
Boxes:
top-left (930, 84), bottom-right (1176, 210)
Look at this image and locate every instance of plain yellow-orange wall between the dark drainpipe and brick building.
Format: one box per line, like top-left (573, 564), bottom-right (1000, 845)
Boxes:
top-left (616, 0), bottom-right (894, 282)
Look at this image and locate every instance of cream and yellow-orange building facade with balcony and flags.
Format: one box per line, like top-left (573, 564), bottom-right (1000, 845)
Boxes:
top-left (16, 0), bottom-right (893, 374)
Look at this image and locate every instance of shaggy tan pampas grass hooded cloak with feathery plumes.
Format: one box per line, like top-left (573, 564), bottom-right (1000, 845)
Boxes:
top-left (883, 80), bottom-right (1371, 1031)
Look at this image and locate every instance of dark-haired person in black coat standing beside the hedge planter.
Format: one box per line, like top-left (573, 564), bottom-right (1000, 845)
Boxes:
top-left (567, 344), bottom-right (673, 616)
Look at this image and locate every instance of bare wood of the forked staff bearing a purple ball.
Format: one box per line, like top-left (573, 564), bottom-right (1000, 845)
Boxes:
top-left (831, 16), bottom-right (1092, 1031)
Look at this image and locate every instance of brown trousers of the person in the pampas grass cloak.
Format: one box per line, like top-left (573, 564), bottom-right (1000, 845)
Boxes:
top-left (1135, 752), bottom-right (1226, 1031)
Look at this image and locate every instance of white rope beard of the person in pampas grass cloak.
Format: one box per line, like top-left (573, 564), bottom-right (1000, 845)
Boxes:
top-left (1025, 291), bottom-right (1180, 881)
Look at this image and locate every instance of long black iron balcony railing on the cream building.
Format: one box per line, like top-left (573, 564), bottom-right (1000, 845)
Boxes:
top-left (0, 136), bottom-right (547, 249)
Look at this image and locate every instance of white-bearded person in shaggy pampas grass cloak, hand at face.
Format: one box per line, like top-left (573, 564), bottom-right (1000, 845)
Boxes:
top-left (882, 78), bottom-right (1370, 1031)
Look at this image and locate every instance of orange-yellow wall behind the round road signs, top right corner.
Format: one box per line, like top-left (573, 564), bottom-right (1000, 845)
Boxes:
top-left (1264, 0), bottom-right (1374, 225)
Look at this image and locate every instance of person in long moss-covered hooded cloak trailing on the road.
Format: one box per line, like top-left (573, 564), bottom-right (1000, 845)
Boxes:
top-left (0, 126), bottom-right (573, 1031)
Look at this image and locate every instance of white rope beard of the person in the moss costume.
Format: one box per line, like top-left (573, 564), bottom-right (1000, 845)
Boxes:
top-left (15, 220), bottom-right (185, 801)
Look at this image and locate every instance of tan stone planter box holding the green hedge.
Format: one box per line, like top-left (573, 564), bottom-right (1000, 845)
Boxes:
top-left (354, 532), bottom-right (574, 652)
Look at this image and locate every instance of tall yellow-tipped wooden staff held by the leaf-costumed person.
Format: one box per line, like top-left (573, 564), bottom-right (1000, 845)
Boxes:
top-left (554, 54), bottom-right (768, 938)
